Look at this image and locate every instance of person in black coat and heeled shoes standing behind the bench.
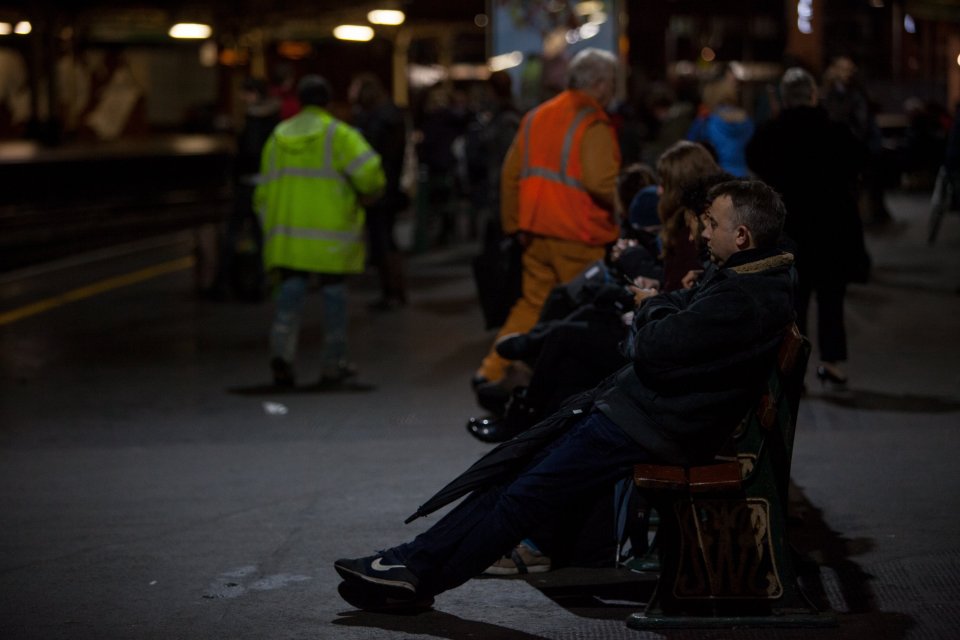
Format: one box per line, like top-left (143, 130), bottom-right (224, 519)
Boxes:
top-left (747, 67), bottom-right (869, 387)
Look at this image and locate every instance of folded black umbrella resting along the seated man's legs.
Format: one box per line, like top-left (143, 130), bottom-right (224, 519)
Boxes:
top-left (404, 389), bottom-right (596, 524)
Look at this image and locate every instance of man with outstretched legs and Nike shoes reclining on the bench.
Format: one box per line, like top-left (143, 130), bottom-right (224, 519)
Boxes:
top-left (334, 180), bottom-right (794, 611)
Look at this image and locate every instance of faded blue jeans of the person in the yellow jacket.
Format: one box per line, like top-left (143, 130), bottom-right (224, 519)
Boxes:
top-left (270, 272), bottom-right (347, 372)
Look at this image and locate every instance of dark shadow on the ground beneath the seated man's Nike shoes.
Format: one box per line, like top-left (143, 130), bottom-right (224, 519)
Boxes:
top-left (333, 610), bottom-right (547, 640)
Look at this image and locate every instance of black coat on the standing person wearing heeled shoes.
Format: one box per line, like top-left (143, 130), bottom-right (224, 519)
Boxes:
top-left (747, 107), bottom-right (867, 280)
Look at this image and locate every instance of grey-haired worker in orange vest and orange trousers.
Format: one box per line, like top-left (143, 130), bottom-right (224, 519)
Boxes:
top-left (473, 48), bottom-right (620, 398)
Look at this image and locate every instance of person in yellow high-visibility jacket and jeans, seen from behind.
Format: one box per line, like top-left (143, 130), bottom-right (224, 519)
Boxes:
top-left (254, 75), bottom-right (385, 387)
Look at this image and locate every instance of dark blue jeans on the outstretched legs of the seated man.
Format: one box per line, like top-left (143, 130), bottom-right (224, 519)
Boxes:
top-left (391, 412), bottom-right (654, 595)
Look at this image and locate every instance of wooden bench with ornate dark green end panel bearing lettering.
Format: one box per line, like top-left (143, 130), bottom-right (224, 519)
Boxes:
top-left (627, 325), bottom-right (835, 629)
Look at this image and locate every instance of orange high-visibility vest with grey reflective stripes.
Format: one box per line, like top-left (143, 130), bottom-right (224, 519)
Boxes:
top-left (517, 90), bottom-right (620, 245)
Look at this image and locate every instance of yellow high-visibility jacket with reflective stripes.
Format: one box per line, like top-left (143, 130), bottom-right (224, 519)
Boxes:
top-left (254, 106), bottom-right (386, 273)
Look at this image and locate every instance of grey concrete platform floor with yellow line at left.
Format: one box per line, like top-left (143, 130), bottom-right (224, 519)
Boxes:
top-left (0, 193), bottom-right (960, 640)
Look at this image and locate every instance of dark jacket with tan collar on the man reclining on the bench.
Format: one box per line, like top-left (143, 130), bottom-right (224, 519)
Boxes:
top-left (596, 250), bottom-right (794, 465)
